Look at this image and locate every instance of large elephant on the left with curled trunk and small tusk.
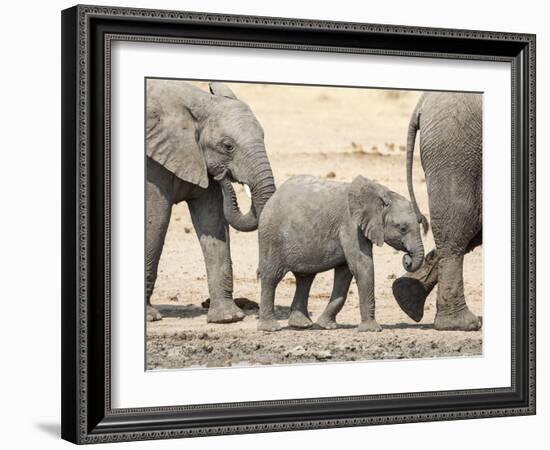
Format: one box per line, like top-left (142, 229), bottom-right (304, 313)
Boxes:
top-left (145, 79), bottom-right (275, 323)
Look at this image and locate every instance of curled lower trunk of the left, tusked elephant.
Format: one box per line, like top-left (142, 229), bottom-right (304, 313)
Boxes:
top-left (220, 158), bottom-right (275, 231)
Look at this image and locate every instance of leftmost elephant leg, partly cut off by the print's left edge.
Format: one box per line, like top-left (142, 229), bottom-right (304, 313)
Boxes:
top-left (145, 166), bottom-right (172, 322)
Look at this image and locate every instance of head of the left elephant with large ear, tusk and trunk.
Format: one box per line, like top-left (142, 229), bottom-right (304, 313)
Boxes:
top-left (146, 79), bottom-right (275, 231)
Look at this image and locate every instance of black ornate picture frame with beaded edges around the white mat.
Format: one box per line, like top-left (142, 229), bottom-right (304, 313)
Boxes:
top-left (61, 5), bottom-right (535, 444)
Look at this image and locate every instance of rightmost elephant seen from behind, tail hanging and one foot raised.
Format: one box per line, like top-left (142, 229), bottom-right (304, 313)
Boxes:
top-left (393, 92), bottom-right (482, 331)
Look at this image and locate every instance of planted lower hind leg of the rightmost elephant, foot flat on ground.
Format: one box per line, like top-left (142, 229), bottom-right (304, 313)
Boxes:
top-left (434, 255), bottom-right (481, 331)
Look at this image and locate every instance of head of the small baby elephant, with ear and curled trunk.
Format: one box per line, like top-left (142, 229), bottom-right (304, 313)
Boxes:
top-left (348, 176), bottom-right (424, 272)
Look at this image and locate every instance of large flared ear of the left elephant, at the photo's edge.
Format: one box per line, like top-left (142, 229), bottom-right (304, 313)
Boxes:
top-left (146, 80), bottom-right (208, 188)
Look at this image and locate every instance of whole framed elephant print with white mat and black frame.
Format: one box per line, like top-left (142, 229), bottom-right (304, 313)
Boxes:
top-left (62, 6), bottom-right (535, 443)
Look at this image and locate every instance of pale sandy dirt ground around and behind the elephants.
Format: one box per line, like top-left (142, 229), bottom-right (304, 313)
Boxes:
top-left (146, 83), bottom-right (482, 369)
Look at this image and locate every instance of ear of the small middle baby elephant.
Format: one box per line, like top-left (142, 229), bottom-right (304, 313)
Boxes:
top-left (348, 176), bottom-right (391, 247)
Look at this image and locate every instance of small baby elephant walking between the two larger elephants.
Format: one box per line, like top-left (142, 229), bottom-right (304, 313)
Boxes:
top-left (258, 176), bottom-right (424, 331)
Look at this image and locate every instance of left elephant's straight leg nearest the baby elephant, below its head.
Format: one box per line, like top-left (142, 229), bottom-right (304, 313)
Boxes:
top-left (187, 183), bottom-right (244, 323)
